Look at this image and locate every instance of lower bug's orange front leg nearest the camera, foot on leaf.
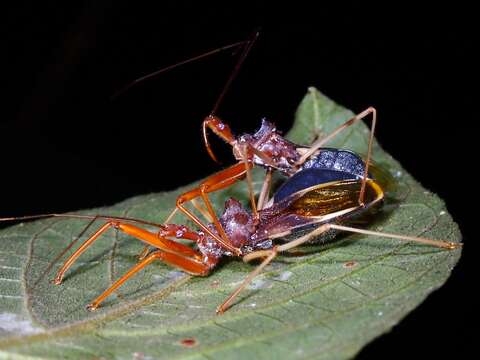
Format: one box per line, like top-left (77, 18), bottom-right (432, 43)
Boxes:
top-left (87, 250), bottom-right (212, 311)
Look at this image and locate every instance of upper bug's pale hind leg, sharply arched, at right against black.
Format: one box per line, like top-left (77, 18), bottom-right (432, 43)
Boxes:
top-left (296, 107), bottom-right (377, 206)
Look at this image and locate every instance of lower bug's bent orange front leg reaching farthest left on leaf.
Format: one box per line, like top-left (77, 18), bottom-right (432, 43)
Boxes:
top-left (54, 221), bottom-right (203, 285)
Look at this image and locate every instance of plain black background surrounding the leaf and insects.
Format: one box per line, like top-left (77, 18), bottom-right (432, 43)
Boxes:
top-left (0, 1), bottom-right (478, 359)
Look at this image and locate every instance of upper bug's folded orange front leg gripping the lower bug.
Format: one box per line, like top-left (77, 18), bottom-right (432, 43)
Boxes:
top-left (177, 162), bottom-right (252, 255)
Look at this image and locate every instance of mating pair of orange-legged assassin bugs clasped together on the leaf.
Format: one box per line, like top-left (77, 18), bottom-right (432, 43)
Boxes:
top-left (0, 36), bottom-right (461, 313)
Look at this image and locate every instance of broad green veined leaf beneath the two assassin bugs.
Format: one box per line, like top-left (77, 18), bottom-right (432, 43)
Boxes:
top-left (0, 88), bottom-right (461, 359)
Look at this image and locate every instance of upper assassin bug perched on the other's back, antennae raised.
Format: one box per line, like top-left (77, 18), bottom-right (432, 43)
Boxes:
top-left (115, 32), bottom-right (376, 258)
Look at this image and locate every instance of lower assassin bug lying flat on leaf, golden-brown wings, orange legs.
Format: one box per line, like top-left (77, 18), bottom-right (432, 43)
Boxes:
top-left (3, 149), bottom-right (461, 313)
